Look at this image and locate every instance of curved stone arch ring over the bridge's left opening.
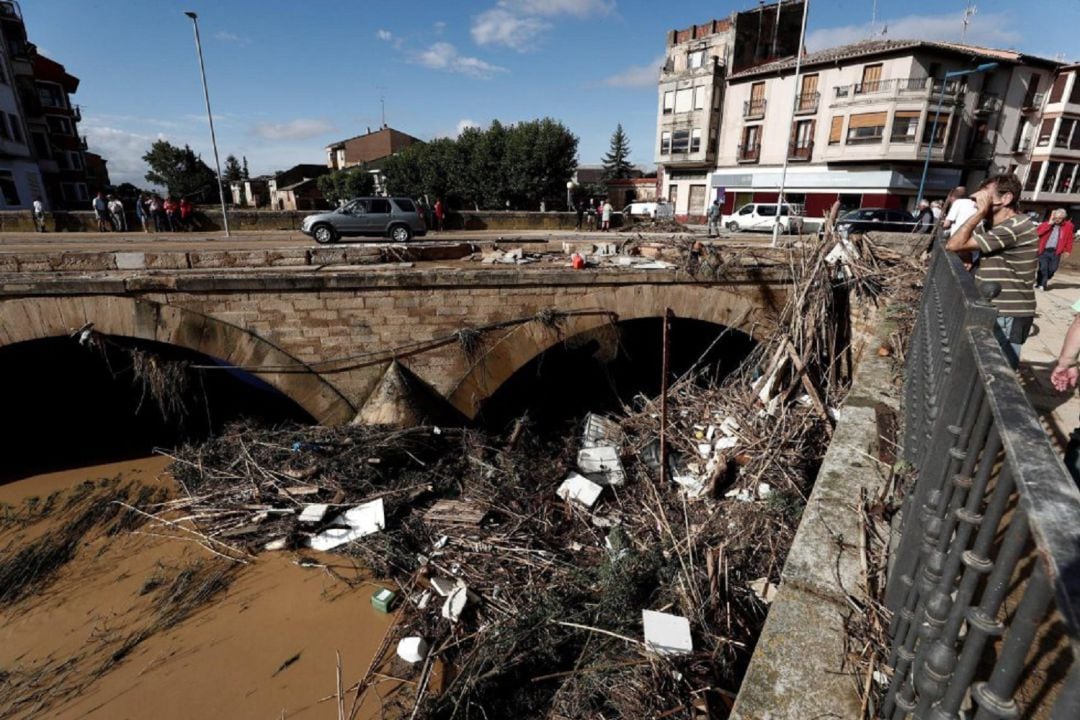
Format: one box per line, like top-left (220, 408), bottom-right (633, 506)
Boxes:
top-left (0, 295), bottom-right (355, 425)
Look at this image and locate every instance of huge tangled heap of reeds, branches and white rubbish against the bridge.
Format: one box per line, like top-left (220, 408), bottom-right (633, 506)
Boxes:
top-left (139, 235), bottom-right (917, 718)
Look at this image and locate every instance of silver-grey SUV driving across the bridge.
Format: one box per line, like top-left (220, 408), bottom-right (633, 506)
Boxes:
top-left (300, 198), bottom-right (428, 245)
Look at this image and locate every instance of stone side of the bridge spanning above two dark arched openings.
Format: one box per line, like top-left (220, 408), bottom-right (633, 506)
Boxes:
top-left (0, 254), bottom-right (788, 424)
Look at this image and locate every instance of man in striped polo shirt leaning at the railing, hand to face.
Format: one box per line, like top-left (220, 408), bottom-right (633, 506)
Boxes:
top-left (945, 174), bottom-right (1039, 367)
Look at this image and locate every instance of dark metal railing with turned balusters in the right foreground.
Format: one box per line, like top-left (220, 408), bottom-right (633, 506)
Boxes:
top-left (880, 244), bottom-right (1080, 720)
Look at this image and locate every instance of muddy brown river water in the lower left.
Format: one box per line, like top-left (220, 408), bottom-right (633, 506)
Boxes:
top-left (0, 457), bottom-right (399, 720)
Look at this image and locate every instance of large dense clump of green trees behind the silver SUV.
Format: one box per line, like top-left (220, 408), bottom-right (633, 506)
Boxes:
top-left (382, 118), bottom-right (578, 209)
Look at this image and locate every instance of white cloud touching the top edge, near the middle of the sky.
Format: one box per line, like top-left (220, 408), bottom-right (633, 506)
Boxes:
top-left (470, 0), bottom-right (615, 52)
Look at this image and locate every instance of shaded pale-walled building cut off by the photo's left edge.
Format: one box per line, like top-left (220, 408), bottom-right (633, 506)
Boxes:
top-left (0, 2), bottom-right (49, 209)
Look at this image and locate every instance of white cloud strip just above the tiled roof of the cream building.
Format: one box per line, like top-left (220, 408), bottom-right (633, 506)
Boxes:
top-left (806, 13), bottom-right (1024, 52)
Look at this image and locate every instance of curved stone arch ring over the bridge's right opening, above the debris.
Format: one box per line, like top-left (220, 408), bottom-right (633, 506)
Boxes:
top-left (446, 283), bottom-right (786, 419)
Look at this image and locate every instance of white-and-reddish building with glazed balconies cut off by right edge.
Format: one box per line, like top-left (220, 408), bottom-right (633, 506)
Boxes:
top-left (1012, 65), bottom-right (1080, 218)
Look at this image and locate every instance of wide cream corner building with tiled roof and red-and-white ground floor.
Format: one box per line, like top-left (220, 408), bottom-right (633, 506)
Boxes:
top-left (710, 40), bottom-right (1058, 217)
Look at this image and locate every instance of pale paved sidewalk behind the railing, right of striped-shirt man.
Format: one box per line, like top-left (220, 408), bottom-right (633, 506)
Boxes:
top-left (1020, 268), bottom-right (1080, 452)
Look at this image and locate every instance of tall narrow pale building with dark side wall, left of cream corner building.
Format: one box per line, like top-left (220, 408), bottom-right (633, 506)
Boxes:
top-left (654, 0), bottom-right (804, 219)
